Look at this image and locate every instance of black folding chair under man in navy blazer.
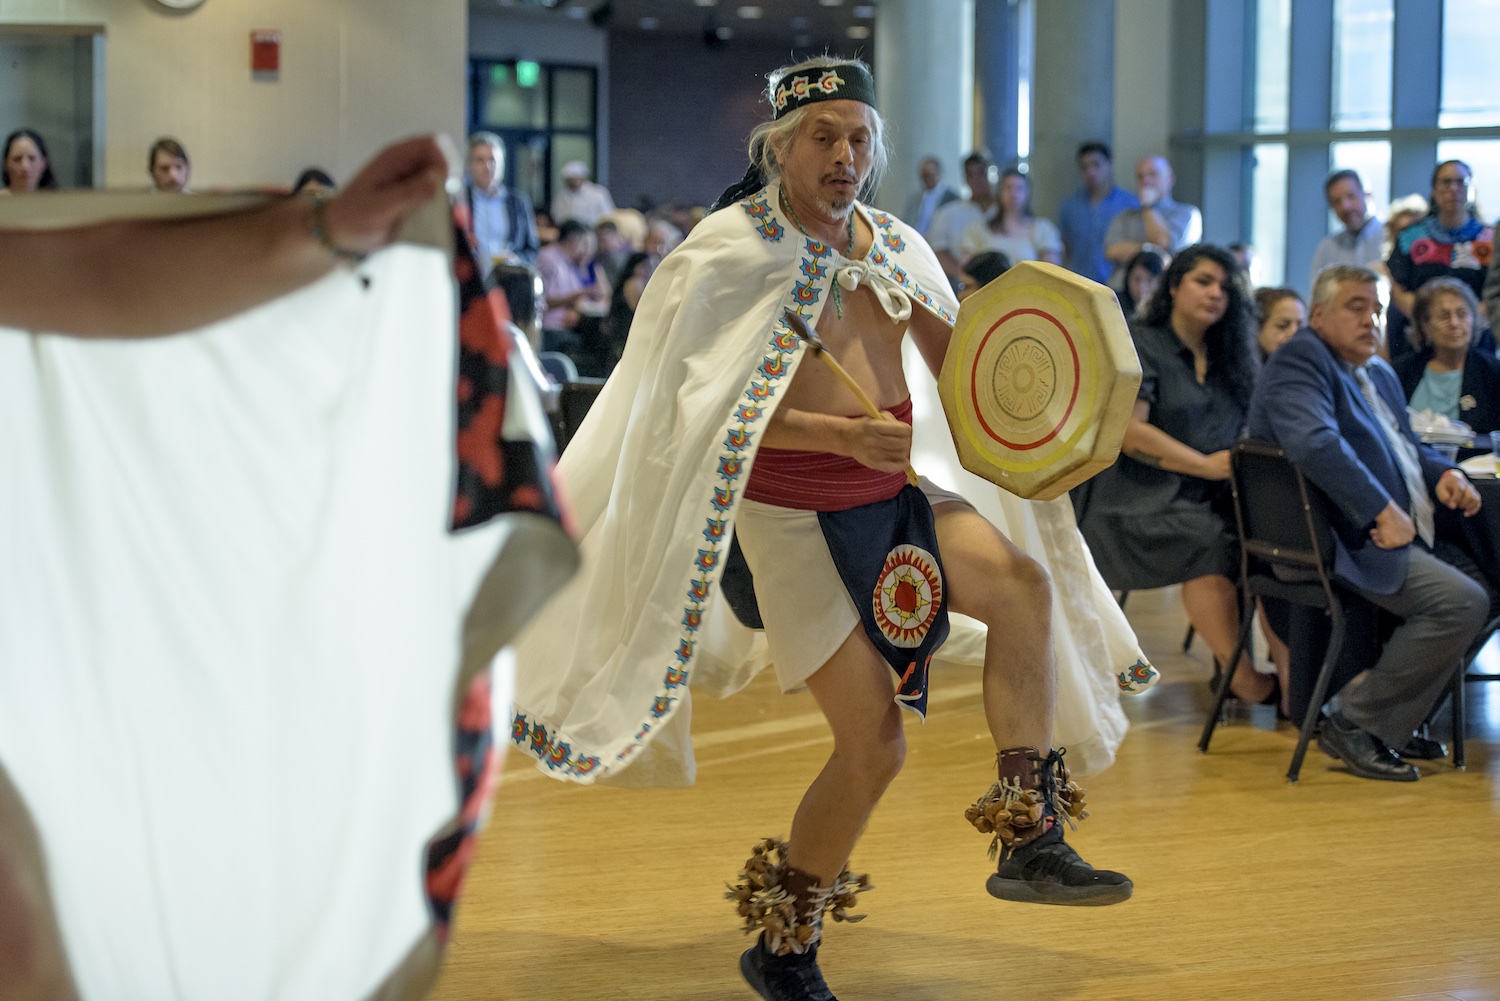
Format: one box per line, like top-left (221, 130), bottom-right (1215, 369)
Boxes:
top-left (1199, 441), bottom-right (1344, 783)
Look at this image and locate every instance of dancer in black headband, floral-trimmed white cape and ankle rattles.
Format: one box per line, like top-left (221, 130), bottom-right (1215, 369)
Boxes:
top-left (512, 57), bottom-right (1131, 1001)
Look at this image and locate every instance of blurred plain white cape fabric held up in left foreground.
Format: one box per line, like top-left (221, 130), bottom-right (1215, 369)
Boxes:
top-left (0, 231), bottom-right (572, 1001)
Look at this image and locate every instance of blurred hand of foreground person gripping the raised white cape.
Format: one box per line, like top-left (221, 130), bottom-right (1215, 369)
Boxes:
top-left (327, 135), bottom-right (449, 254)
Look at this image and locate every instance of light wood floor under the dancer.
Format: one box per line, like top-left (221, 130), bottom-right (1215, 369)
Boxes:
top-left (435, 590), bottom-right (1500, 1001)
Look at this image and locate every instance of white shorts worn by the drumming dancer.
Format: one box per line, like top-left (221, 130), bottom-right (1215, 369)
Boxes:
top-left (735, 476), bottom-right (969, 692)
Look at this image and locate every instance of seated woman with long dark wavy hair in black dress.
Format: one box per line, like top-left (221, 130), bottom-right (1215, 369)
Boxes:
top-left (1079, 243), bottom-right (1278, 704)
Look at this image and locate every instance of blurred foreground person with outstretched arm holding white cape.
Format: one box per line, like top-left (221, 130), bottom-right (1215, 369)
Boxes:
top-left (0, 138), bottom-right (573, 1001)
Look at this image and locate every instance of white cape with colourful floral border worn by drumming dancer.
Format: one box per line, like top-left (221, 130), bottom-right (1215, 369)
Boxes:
top-left (512, 191), bottom-right (1145, 785)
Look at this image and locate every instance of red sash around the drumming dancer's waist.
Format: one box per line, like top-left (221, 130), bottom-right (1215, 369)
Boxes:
top-left (744, 396), bottom-right (912, 510)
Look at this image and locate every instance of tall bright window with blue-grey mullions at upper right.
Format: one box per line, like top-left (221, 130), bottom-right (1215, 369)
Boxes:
top-left (1176, 0), bottom-right (1500, 291)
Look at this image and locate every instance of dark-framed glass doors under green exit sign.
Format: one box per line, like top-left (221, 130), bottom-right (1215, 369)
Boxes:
top-left (470, 59), bottom-right (599, 209)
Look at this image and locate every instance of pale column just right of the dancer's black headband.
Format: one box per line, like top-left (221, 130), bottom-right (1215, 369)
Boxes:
top-left (875, 0), bottom-right (975, 213)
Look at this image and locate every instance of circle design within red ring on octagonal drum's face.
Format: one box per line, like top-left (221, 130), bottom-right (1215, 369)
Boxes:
top-left (969, 308), bottom-right (1080, 452)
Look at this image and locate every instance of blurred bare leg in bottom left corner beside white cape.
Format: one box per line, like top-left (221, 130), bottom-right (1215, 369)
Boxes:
top-left (0, 767), bottom-right (78, 1001)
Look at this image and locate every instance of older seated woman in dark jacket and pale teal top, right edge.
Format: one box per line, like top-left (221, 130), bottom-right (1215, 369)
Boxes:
top-left (1392, 278), bottom-right (1500, 435)
